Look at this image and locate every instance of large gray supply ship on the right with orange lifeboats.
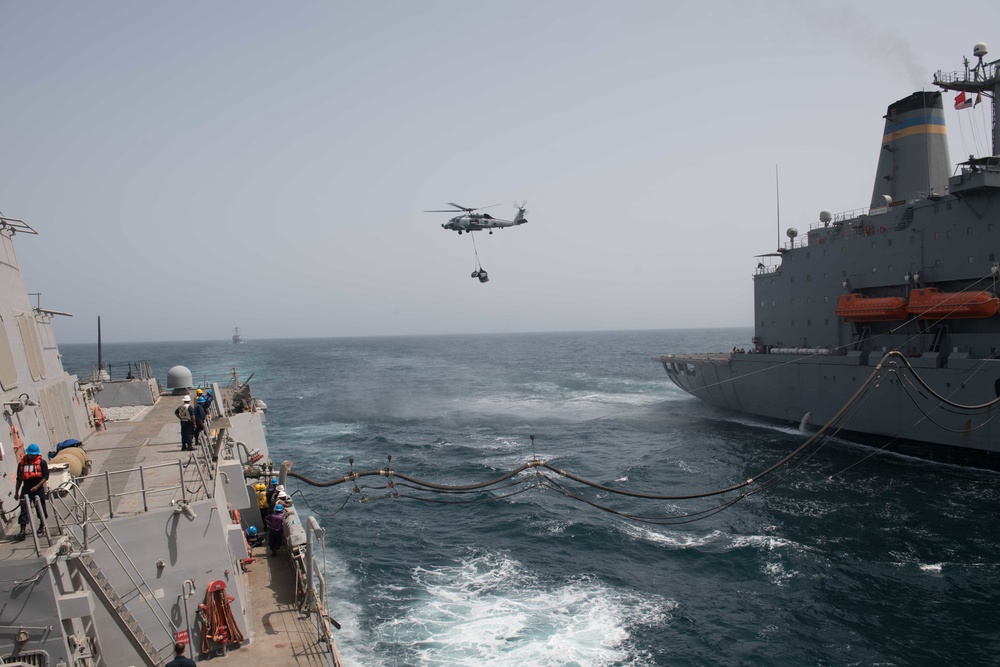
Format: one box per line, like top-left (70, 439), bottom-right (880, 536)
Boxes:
top-left (657, 43), bottom-right (1000, 469)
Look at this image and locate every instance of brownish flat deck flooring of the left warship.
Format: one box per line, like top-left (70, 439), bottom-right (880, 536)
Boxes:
top-left (0, 396), bottom-right (336, 667)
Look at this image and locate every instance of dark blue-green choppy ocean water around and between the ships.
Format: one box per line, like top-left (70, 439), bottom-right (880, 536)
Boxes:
top-left (62, 329), bottom-right (1000, 667)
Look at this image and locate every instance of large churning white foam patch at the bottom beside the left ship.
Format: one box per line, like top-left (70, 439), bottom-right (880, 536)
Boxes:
top-left (378, 554), bottom-right (676, 667)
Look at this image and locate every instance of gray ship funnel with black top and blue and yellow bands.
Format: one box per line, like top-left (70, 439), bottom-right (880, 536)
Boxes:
top-left (871, 92), bottom-right (951, 208)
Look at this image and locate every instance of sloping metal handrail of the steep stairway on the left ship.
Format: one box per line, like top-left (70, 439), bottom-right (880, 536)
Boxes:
top-left (50, 478), bottom-right (183, 655)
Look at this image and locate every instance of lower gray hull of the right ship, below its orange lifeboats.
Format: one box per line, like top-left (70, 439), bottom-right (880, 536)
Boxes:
top-left (659, 353), bottom-right (1000, 470)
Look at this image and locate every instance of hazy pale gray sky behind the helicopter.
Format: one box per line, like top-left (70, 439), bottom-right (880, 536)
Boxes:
top-left (0, 0), bottom-right (1000, 343)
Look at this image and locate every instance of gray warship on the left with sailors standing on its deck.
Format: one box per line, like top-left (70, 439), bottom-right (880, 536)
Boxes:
top-left (0, 218), bottom-right (341, 667)
